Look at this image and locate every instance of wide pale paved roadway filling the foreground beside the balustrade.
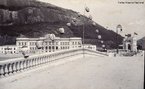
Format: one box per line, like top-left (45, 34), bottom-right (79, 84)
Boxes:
top-left (0, 56), bottom-right (144, 89)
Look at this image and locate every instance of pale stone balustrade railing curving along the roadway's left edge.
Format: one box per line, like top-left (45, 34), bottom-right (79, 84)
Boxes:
top-left (0, 49), bottom-right (106, 77)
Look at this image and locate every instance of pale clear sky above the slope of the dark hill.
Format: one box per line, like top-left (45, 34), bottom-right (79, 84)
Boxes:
top-left (39, 0), bottom-right (145, 39)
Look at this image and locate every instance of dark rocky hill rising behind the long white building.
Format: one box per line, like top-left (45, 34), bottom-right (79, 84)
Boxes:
top-left (0, 0), bottom-right (122, 48)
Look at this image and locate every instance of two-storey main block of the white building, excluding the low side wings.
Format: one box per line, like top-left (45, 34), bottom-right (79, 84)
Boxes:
top-left (16, 34), bottom-right (82, 53)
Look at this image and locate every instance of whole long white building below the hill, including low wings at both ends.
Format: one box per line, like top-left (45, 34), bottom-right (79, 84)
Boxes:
top-left (0, 34), bottom-right (96, 54)
